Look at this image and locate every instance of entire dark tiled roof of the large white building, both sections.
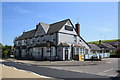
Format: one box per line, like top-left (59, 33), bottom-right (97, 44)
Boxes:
top-left (16, 19), bottom-right (69, 40)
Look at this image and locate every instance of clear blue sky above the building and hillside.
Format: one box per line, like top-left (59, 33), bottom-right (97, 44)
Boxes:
top-left (0, 2), bottom-right (118, 45)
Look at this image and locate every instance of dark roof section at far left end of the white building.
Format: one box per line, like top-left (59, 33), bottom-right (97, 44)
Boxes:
top-left (16, 29), bottom-right (36, 40)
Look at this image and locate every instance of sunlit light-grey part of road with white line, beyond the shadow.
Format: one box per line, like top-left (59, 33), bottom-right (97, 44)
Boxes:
top-left (43, 58), bottom-right (118, 77)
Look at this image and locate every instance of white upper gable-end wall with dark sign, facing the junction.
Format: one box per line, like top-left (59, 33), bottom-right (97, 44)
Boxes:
top-left (58, 21), bottom-right (90, 53)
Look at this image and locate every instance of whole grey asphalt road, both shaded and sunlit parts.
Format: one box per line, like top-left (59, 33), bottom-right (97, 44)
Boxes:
top-left (3, 59), bottom-right (118, 79)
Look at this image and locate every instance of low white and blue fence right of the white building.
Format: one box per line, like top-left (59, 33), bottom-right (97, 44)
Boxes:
top-left (82, 53), bottom-right (110, 59)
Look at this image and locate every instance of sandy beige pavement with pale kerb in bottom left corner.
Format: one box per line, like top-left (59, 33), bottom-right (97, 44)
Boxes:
top-left (0, 60), bottom-right (54, 79)
